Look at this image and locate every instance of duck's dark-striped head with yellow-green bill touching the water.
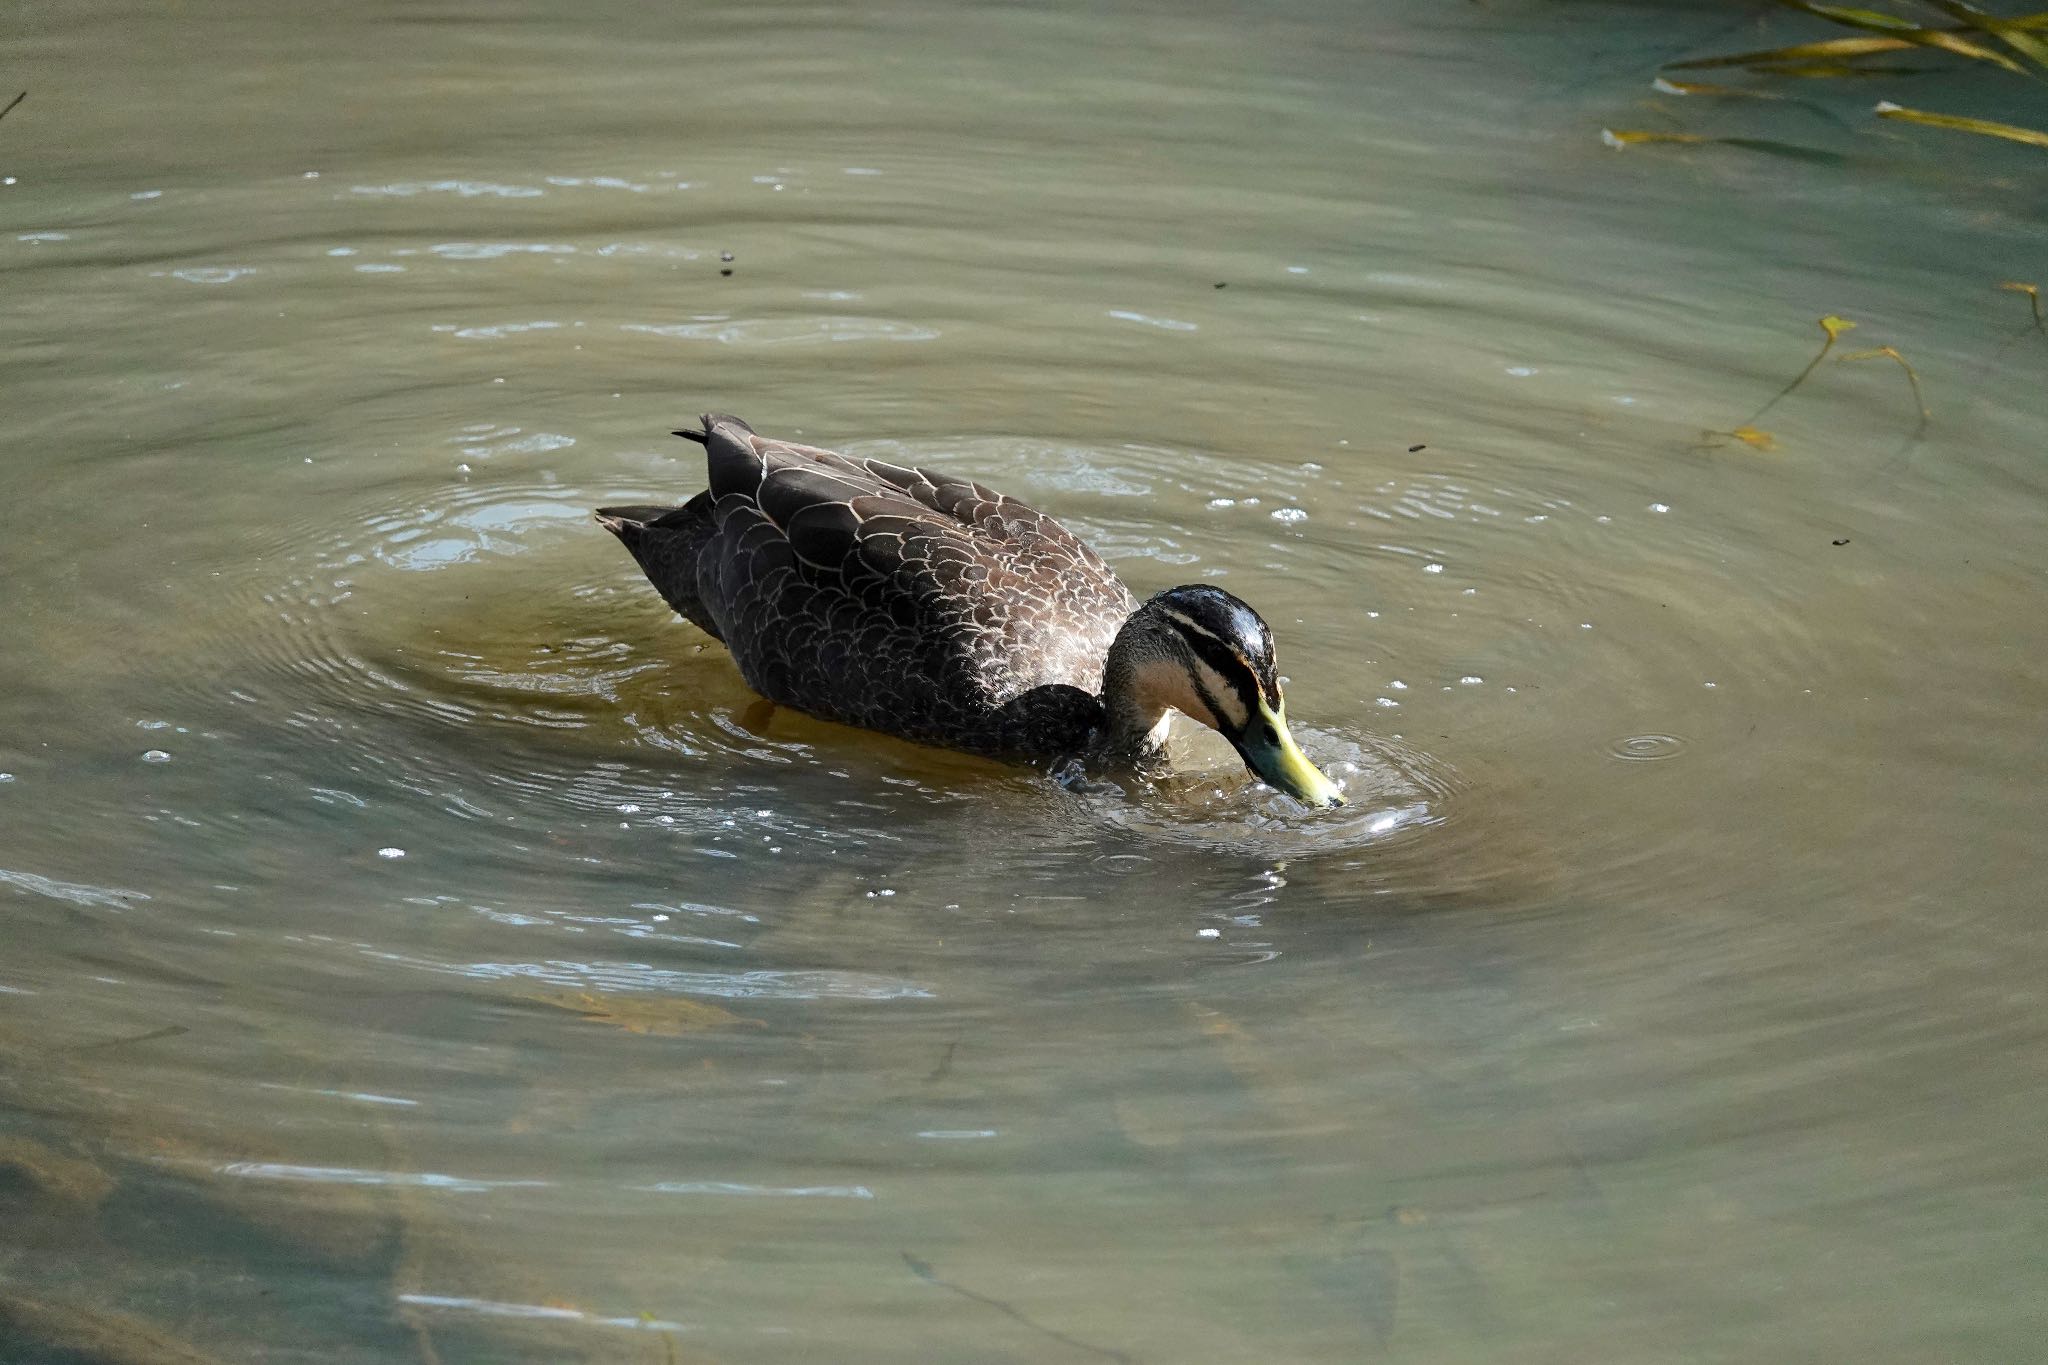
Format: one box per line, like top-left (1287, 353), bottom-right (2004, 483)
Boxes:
top-left (1104, 583), bottom-right (1343, 806)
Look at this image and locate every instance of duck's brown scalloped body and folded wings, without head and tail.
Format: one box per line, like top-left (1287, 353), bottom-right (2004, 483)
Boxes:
top-left (672, 415), bottom-right (1137, 753)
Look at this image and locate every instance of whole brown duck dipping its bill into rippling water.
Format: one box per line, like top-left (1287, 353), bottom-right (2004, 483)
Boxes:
top-left (594, 413), bottom-right (1343, 806)
